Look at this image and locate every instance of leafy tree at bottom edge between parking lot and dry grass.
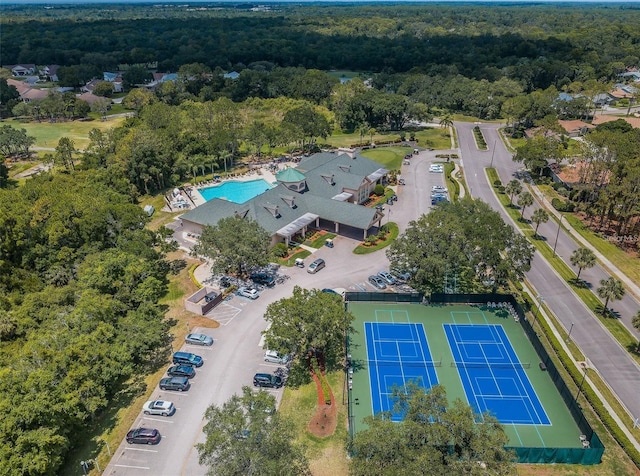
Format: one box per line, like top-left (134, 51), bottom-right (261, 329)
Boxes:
top-left (196, 387), bottom-right (310, 476)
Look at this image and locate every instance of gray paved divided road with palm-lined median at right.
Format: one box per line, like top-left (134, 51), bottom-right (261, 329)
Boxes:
top-left (455, 123), bottom-right (640, 417)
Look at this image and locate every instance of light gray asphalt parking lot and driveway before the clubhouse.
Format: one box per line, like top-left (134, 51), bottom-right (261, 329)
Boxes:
top-left (104, 148), bottom-right (444, 476)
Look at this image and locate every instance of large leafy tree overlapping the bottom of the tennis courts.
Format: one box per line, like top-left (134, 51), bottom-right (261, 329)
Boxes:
top-left (349, 382), bottom-right (515, 476)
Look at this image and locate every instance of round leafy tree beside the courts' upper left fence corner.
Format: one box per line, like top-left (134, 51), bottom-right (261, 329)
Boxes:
top-left (264, 286), bottom-right (353, 372)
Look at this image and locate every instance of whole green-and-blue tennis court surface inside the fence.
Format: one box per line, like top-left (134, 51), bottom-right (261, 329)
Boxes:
top-left (348, 301), bottom-right (582, 448)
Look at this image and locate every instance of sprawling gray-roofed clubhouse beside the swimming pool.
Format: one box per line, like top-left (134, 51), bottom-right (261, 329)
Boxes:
top-left (180, 152), bottom-right (388, 244)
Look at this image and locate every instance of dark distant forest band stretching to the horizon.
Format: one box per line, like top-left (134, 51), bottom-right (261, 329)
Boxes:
top-left (0, 4), bottom-right (640, 92)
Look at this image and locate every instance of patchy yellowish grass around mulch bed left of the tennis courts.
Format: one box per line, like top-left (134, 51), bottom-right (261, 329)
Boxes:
top-left (278, 371), bottom-right (349, 476)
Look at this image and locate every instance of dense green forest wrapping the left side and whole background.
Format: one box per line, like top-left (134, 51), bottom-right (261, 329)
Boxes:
top-left (0, 4), bottom-right (640, 475)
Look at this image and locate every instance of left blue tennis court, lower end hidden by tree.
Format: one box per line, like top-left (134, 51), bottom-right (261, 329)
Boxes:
top-left (364, 322), bottom-right (438, 421)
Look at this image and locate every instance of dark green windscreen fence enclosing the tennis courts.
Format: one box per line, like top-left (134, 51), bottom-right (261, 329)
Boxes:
top-left (345, 292), bottom-right (604, 465)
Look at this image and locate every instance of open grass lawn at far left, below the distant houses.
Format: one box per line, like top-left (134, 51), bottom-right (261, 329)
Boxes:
top-left (2, 117), bottom-right (124, 149)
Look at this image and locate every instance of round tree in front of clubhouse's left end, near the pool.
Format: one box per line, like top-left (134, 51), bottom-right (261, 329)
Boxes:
top-left (193, 216), bottom-right (271, 275)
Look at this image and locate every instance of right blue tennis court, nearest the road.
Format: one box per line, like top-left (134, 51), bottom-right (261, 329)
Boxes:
top-left (443, 324), bottom-right (550, 425)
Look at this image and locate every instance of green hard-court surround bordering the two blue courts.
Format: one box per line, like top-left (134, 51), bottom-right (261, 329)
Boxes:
top-left (349, 302), bottom-right (581, 448)
